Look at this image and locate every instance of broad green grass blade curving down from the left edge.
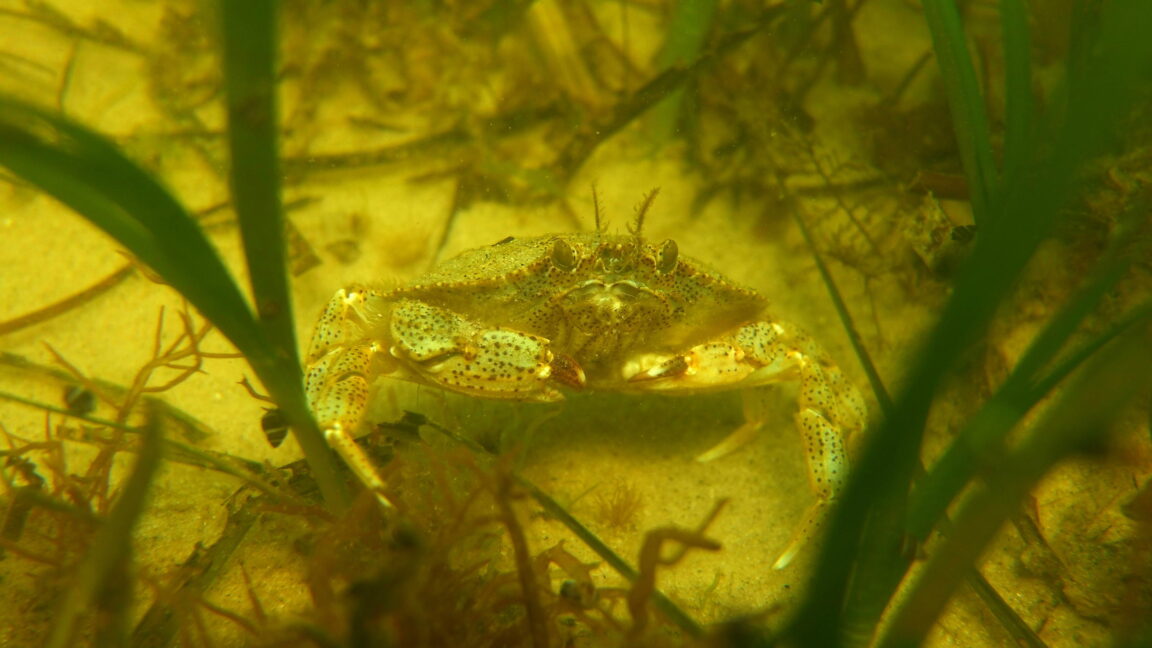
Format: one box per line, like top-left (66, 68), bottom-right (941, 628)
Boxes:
top-left (0, 96), bottom-right (348, 508)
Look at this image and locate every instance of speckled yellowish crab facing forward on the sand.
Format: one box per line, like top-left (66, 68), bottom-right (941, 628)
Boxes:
top-left (305, 191), bottom-right (866, 568)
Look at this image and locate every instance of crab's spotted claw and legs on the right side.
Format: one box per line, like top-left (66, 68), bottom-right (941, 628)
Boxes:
top-left (627, 322), bottom-right (866, 568)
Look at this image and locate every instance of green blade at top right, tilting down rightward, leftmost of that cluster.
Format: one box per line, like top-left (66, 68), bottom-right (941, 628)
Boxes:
top-left (923, 0), bottom-right (999, 228)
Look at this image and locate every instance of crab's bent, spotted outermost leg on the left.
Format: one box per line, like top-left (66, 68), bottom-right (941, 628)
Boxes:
top-left (304, 287), bottom-right (393, 508)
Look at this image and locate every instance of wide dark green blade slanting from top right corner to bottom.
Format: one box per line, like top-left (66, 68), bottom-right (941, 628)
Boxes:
top-left (786, 2), bottom-right (1152, 646)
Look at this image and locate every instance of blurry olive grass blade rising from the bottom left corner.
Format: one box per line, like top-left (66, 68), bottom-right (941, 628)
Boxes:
top-left (45, 401), bottom-right (166, 648)
